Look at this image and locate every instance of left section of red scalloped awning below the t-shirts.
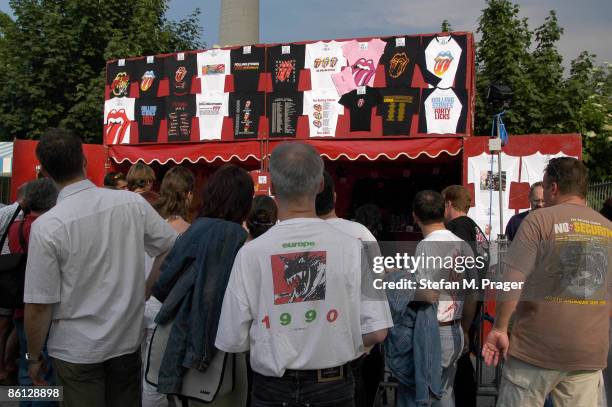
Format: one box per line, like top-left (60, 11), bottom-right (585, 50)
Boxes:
top-left (108, 141), bottom-right (262, 164)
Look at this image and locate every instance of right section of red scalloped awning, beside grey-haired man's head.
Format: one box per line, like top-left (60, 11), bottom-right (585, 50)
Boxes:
top-left (269, 137), bottom-right (463, 161)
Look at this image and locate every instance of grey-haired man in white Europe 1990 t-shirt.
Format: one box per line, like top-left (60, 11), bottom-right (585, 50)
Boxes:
top-left (216, 143), bottom-right (393, 407)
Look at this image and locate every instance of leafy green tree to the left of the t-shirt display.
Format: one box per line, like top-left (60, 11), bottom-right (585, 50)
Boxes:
top-left (0, 0), bottom-right (204, 142)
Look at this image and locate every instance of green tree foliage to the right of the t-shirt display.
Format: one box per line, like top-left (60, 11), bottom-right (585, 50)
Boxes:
top-left (475, 0), bottom-right (612, 181)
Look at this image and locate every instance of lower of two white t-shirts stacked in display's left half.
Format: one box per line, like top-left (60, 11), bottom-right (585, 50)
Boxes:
top-left (196, 92), bottom-right (229, 140)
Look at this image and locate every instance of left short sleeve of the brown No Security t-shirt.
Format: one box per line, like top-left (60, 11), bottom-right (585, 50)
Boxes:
top-left (504, 212), bottom-right (546, 276)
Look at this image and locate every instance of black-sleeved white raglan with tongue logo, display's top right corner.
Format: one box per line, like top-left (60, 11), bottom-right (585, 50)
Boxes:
top-left (421, 35), bottom-right (467, 89)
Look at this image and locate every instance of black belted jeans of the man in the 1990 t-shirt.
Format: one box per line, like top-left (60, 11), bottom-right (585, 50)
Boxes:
top-left (251, 366), bottom-right (355, 407)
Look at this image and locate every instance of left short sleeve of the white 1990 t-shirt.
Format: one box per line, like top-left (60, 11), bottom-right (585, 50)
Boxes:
top-left (215, 249), bottom-right (253, 353)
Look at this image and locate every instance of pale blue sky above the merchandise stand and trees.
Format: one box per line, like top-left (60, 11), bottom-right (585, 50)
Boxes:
top-left (0, 0), bottom-right (612, 66)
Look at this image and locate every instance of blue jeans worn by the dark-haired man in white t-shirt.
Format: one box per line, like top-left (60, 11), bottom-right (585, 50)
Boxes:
top-left (432, 323), bottom-right (463, 407)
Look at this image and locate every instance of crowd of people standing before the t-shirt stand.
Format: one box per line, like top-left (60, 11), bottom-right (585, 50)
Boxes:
top-left (0, 129), bottom-right (612, 407)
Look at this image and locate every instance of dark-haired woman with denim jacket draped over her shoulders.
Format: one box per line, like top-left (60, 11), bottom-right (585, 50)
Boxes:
top-left (150, 165), bottom-right (254, 406)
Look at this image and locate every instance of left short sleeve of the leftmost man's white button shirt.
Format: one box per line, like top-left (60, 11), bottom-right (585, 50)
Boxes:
top-left (23, 222), bottom-right (64, 304)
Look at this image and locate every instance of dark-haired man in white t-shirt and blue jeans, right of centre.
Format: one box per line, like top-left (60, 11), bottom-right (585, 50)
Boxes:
top-left (412, 191), bottom-right (473, 407)
